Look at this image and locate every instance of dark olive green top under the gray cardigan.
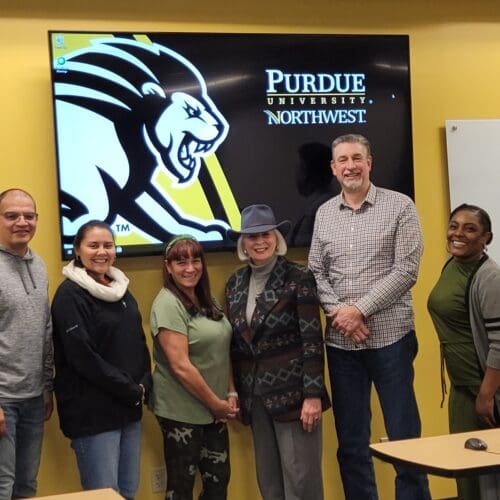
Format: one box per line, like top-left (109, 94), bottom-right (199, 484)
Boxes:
top-left (427, 259), bottom-right (482, 387)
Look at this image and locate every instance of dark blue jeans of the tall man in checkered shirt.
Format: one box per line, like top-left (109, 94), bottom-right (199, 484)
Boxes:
top-left (327, 331), bottom-right (431, 500)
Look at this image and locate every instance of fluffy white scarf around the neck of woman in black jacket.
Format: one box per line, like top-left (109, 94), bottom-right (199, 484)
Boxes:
top-left (63, 260), bottom-right (129, 302)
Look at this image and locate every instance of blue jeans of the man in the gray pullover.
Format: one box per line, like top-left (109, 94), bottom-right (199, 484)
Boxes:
top-left (0, 396), bottom-right (44, 500)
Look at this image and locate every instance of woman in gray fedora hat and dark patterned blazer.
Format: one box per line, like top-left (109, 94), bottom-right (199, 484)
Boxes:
top-left (226, 205), bottom-right (330, 500)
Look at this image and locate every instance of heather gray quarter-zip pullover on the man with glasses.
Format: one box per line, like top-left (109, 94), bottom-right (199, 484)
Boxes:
top-left (0, 245), bottom-right (54, 400)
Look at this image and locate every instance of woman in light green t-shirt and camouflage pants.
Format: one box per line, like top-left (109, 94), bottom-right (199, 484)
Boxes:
top-left (150, 235), bottom-right (238, 500)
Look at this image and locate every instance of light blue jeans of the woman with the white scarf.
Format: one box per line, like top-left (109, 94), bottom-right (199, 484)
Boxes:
top-left (71, 421), bottom-right (141, 499)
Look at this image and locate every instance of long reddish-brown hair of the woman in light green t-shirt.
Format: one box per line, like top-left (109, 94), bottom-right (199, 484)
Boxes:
top-left (163, 236), bottom-right (223, 321)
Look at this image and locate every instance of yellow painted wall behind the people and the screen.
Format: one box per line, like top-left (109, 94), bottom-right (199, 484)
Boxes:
top-left (0, 0), bottom-right (500, 500)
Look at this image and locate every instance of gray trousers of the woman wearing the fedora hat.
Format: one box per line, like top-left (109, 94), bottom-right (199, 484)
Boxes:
top-left (252, 398), bottom-right (323, 500)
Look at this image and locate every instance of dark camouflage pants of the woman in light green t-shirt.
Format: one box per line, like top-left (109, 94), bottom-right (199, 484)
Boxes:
top-left (156, 416), bottom-right (230, 500)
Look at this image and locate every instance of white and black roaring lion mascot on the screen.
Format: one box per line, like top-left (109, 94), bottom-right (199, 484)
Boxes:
top-left (54, 38), bottom-right (229, 243)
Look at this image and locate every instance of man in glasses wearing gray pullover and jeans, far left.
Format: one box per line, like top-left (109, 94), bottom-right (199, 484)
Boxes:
top-left (0, 189), bottom-right (53, 500)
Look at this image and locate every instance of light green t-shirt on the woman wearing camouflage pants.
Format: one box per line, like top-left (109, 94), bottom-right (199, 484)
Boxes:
top-left (149, 288), bottom-right (231, 424)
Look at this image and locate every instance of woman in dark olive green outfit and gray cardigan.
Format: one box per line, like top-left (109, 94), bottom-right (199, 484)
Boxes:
top-left (428, 204), bottom-right (500, 500)
